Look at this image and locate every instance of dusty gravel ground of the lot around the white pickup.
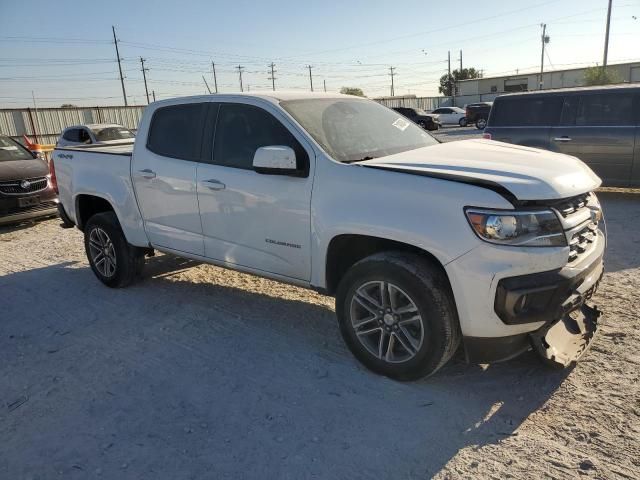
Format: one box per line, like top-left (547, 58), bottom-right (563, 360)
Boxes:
top-left (0, 189), bottom-right (640, 480)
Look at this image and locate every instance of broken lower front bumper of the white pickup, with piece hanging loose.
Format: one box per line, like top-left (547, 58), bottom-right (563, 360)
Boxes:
top-left (464, 236), bottom-right (604, 367)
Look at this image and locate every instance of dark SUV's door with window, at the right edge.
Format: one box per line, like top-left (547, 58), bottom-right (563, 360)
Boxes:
top-left (551, 91), bottom-right (637, 186)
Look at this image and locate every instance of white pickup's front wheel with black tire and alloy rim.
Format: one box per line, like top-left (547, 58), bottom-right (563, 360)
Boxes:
top-left (336, 252), bottom-right (461, 380)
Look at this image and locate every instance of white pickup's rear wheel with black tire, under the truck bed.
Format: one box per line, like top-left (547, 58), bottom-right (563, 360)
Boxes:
top-left (84, 212), bottom-right (144, 288)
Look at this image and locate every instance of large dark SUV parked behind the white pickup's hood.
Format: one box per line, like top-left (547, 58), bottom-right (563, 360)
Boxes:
top-left (485, 85), bottom-right (640, 187)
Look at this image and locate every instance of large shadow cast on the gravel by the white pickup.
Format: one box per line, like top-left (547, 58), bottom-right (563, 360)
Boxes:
top-left (0, 256), bottom-right (567, 479)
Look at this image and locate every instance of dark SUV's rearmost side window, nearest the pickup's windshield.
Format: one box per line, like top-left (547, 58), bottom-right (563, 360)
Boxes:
top-left (492, 95), bottom-right (563, 127)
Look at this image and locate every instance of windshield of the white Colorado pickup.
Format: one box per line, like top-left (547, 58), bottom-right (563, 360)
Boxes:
top-left (281, 98), bottom-right (438, 162)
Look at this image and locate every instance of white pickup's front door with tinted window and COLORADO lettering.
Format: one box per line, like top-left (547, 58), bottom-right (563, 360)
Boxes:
top-left (197, 103), bottom-right (313, 281)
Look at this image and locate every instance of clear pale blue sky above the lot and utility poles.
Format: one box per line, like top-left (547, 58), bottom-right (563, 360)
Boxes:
top-left (0, 0), bottom-right (640, 108)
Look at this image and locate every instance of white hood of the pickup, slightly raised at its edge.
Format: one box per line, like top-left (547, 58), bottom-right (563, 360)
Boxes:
top-left (358, 140), bottom-right (602, 201)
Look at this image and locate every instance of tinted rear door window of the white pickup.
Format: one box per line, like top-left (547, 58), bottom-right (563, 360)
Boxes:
top-left (147, 103), bottom-right (207, 161)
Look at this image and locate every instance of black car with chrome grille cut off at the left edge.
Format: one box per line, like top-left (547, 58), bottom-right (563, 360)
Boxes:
top-left (0, 135), bottom-right (58, 225)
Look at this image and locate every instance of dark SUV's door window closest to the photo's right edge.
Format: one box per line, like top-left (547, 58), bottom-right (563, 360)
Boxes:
top-left (575, 93), bottom-right (634, 126)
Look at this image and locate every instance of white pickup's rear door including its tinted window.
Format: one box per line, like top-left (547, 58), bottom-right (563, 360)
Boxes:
top-left (131, 103), bottom-right (209, 255)
